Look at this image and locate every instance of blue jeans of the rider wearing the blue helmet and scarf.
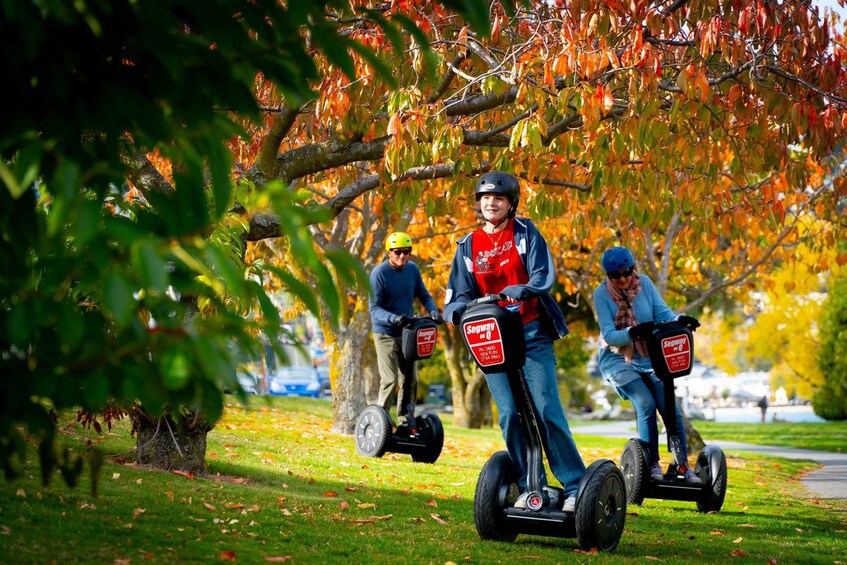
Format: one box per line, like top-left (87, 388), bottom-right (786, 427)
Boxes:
top-left (616, 371), bottom-right (688, 465)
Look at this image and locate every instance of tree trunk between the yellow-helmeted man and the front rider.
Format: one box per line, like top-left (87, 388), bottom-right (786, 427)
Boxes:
top-left (441, 326), bottom-right (493, 429)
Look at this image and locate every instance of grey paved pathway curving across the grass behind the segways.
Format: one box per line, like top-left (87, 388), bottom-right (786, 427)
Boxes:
top-left (571, 421), bottom-right (847, 500)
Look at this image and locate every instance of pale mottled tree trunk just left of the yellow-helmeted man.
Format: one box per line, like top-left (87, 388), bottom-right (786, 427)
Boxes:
top-left (324, 301), bottom-right (374, 434)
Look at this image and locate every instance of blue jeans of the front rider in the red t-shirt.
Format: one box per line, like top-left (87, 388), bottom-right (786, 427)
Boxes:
top-left (486, 320), bottom-right (585, 496)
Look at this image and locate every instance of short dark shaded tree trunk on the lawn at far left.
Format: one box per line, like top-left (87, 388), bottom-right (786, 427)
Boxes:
top-left (130, 407), bottom-right (213, 475)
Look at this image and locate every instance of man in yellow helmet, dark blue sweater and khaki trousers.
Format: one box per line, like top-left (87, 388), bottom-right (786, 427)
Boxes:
top-left (370, 232), bottom-right (442, 427)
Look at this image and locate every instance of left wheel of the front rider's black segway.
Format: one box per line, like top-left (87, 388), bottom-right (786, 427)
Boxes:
top-left (474, 451), bottom-right (518, 541)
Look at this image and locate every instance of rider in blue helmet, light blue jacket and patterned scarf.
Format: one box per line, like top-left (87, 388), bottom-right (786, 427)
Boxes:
top-left (594, 247), bottom-right (701, 483)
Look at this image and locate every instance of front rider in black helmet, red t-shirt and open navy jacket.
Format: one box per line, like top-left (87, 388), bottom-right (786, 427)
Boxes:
top-left (444, 172), bottom-right (585, 512)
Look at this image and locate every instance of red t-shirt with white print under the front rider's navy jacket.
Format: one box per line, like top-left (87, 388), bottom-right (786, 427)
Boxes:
top-left (471, 220), bottom-right (538, 324)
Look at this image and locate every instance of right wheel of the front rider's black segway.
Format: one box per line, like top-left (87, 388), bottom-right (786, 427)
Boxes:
top-left (575, 459), bottom-right (626, 551)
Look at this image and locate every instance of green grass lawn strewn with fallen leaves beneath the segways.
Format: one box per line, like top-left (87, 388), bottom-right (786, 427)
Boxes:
top-left (0, 398), bottom-right (847, 564)
